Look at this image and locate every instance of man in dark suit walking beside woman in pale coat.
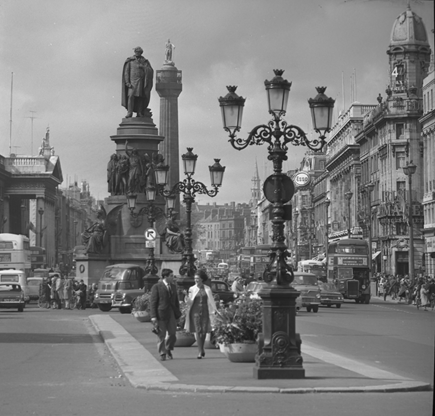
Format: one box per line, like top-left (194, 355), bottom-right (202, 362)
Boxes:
top-left (150, 269), bottom-right (181, 361)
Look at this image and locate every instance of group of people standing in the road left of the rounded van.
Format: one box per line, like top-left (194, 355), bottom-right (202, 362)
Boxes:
top-left (39, 273), bottom-right (88, 310)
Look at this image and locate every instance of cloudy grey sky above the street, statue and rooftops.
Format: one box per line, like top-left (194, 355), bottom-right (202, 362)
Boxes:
top-left (0, 0), bottom-right (434, 203)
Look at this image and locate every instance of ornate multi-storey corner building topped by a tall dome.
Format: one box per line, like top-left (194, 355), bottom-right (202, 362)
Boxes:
top-left (354, 7), bottom-right (433, 275)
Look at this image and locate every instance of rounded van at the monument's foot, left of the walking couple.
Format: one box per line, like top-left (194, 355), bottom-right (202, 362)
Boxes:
top-left (94, 263), bottom-right (145, 313)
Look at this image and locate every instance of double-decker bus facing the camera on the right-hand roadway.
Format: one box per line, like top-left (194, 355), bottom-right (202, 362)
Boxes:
top-left (328, 238), bottom-right (370, 304)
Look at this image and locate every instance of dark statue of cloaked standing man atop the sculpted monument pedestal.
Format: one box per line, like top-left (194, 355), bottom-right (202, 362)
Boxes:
top-left (121, 47), bottom-right (154, 118)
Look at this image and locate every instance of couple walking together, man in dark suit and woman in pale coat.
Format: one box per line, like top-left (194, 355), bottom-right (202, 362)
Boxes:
top-left (150, 269), bottom-right (216, 361)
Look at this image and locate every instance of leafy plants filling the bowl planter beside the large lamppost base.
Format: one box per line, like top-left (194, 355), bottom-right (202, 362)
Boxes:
top-left (213, 295), bottom-right (263, 345)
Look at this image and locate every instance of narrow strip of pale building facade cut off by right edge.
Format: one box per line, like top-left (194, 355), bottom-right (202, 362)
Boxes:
top-left (420, 52), bottom-right (435, 276)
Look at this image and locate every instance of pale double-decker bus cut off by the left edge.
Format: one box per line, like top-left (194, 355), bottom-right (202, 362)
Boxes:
top-left (0, 233), bottom-right (32, 277)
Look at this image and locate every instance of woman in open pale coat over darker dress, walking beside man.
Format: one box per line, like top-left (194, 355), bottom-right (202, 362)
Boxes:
top-left (184, 270), bottom-right (216, 359)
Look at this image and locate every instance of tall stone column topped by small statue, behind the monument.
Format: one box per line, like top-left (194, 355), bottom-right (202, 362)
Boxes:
top-left (156, 40), bottom-right (182, 211)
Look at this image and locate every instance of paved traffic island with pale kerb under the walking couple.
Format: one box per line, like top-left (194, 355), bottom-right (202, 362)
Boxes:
top-left (89, 314), bottom-right (432, 394)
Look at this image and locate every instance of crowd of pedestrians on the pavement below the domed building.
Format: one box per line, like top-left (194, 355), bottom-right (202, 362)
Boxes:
top-left (376, 273), bottom-right (435, 310)
